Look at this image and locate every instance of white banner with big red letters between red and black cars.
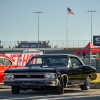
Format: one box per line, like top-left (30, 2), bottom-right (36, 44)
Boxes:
top-left (5, 52), bottom-right (43, 66)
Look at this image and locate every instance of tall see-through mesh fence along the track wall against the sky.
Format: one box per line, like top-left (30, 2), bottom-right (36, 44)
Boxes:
top-left (0, 40), bottom-right (90, 48)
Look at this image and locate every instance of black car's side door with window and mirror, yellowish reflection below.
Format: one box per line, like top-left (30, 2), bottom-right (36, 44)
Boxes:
top-left (68, 56), bottom-right (83, 84)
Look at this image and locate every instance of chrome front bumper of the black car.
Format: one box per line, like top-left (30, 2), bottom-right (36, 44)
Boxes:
top-left (4, 79), bottom-right (59, 87)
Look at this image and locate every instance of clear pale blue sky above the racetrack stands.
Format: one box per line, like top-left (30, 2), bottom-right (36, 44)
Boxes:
top-left (0, 0), bottom-right (100, 41)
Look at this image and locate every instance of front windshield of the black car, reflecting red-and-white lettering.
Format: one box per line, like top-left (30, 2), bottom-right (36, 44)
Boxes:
top-left (26, 56), bottom-right (68, 67)
